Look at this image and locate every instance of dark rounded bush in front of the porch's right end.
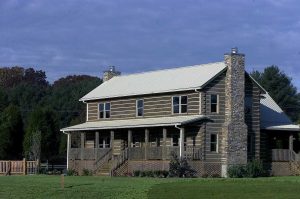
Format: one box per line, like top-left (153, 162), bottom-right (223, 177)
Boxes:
top-left (169, 152), bottom-right (196, 178)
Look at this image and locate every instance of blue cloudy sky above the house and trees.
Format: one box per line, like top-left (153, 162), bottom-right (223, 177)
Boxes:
top-left (0, 0), bottom-right (300, 90)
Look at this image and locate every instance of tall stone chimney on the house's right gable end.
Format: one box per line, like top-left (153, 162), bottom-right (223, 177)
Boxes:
top-left (221, 48), bottom-right (247, 177)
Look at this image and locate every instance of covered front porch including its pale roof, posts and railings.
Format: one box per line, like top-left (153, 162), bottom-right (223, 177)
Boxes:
top-left (64, 116), bottom-right (205, 173)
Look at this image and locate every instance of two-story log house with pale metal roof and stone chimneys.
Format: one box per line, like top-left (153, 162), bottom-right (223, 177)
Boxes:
top-left (61, 48), bottom-right (299, 177)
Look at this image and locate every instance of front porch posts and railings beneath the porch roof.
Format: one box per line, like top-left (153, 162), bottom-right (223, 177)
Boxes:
top-left (67, 127), bottom-right (203, 162)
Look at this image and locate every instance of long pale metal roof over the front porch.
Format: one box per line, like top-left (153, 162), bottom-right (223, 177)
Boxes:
top-left (61, 115), bottom-right (208, 132)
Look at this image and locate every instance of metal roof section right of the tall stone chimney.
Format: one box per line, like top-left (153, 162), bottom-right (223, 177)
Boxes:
top-left (260, 93), bottom-right (300, 131)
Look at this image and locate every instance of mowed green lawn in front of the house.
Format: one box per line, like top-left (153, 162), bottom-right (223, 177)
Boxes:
top-left (0, 175), bottom-right (300, 199)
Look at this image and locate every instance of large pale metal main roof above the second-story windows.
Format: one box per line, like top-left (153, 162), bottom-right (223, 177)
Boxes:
top-left (80, 62), bottom-right (226, 101)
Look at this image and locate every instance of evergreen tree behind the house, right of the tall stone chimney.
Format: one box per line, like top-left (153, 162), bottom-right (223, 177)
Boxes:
top-left (251, 65), bottom-right (300, 121)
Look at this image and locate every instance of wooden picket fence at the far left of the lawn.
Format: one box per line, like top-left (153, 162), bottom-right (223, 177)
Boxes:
top-left (0, 159), bottom-right (39, 175)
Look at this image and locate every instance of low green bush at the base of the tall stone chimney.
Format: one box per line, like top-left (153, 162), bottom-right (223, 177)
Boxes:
top-left (228, 160), bottom-right (268, 178)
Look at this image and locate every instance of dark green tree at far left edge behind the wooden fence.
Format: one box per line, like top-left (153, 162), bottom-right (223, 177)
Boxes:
top-left (0, 105), bottom-right (24, 159)
